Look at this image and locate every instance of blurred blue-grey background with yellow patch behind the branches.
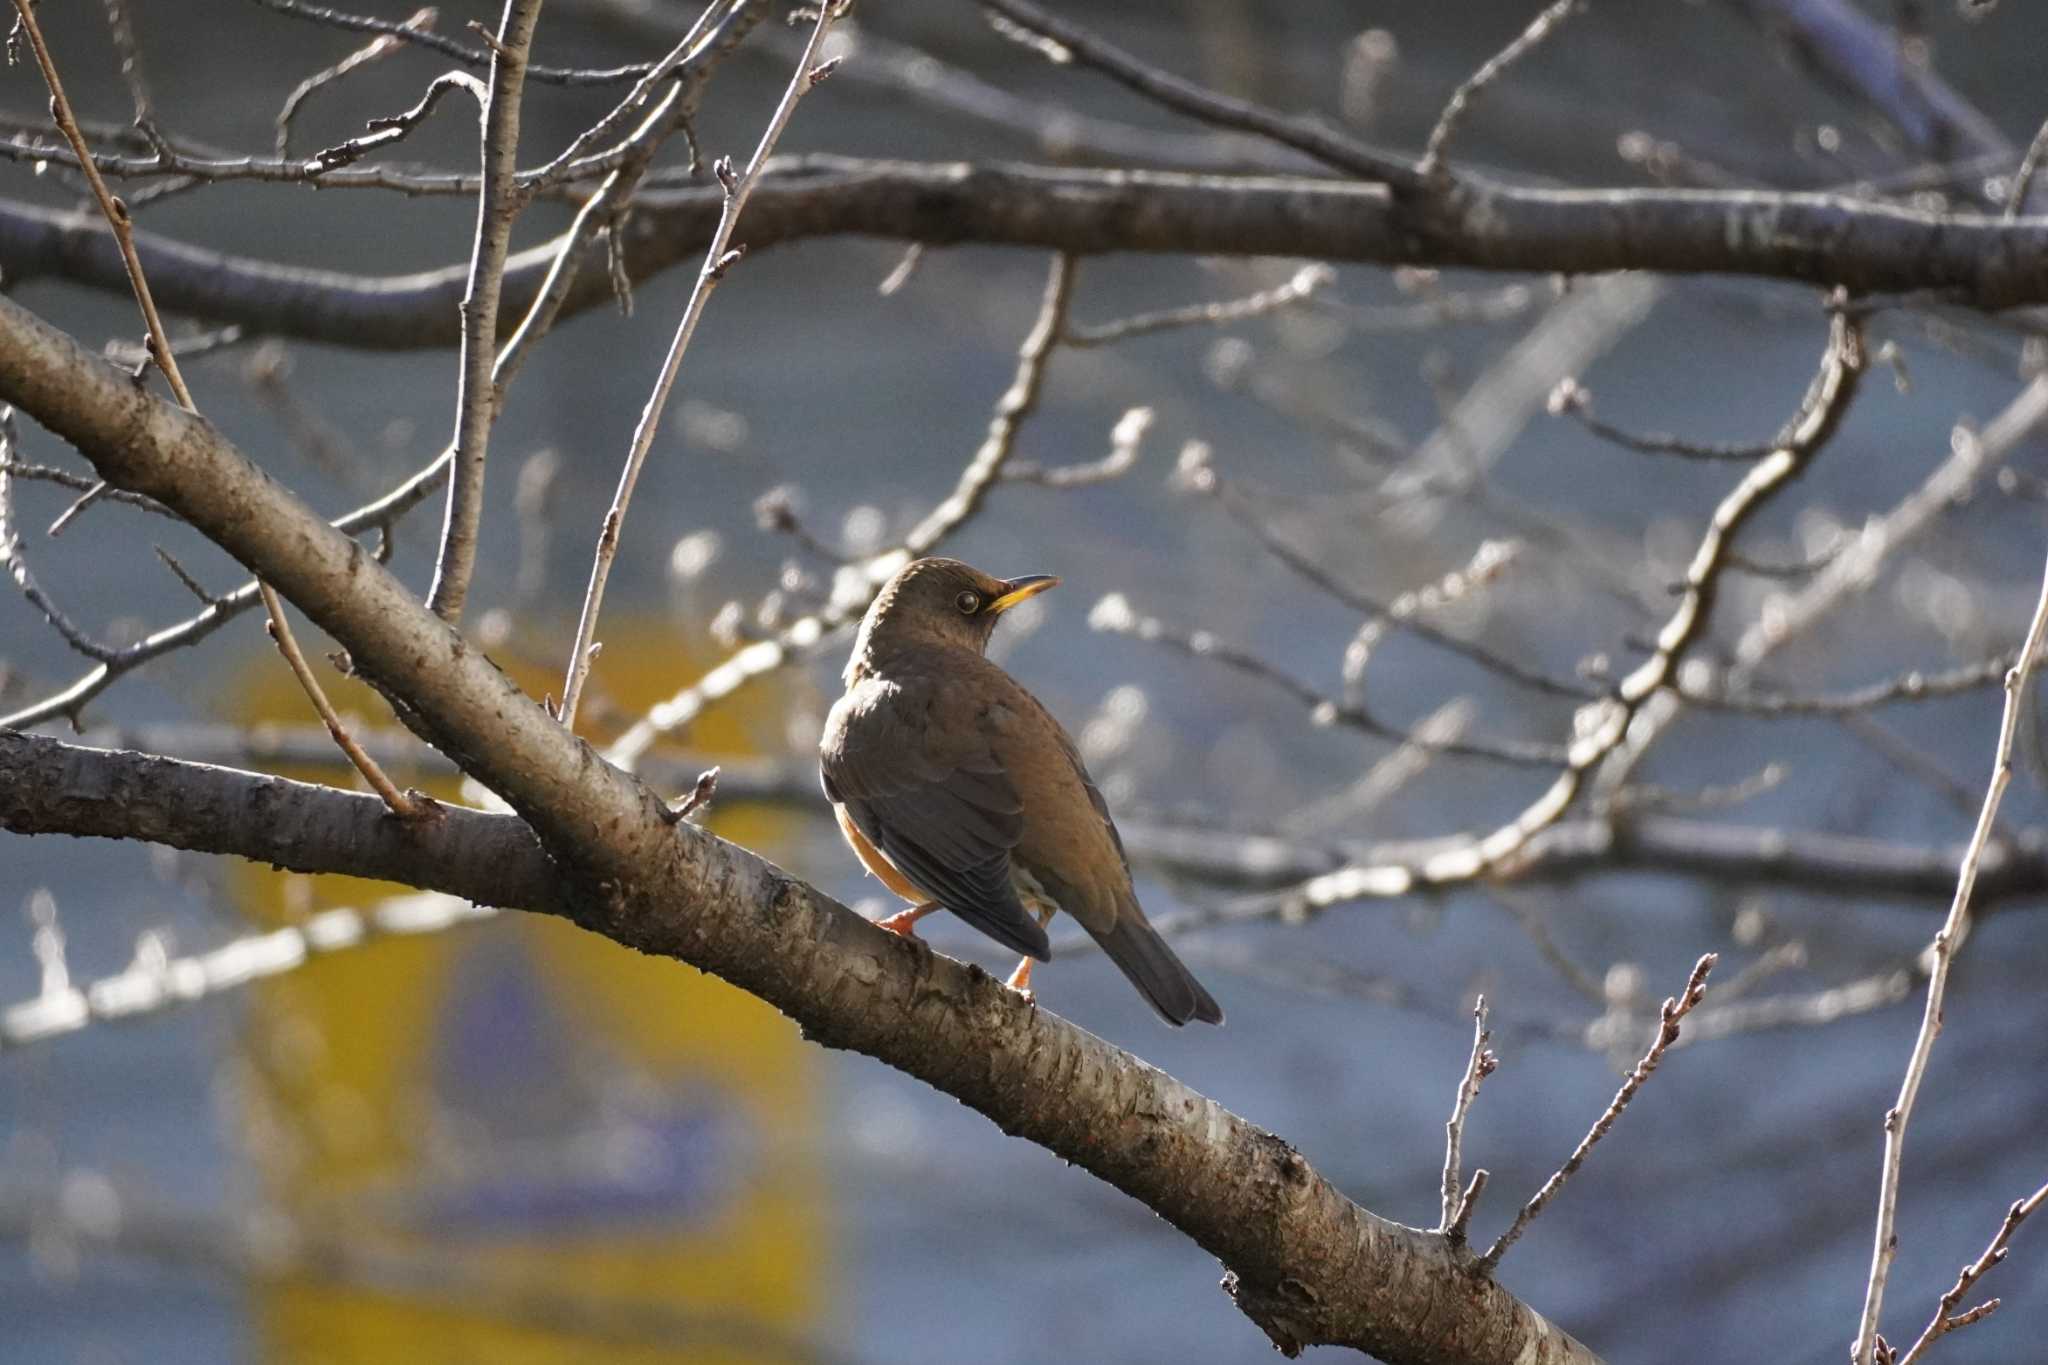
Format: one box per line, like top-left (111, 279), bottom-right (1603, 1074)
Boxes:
top-left (0, 0), bottom-right (2048, 1363)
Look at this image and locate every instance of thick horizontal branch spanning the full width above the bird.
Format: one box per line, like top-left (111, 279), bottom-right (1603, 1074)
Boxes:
top-left (0, 158), bottom-right (2048, 350)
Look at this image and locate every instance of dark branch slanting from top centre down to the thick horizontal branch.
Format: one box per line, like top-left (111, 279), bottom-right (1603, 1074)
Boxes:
top-left (981, 0), bottom-right (1419, 188)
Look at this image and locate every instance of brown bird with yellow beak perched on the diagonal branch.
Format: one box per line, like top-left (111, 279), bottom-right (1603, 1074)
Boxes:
top-left (819, 557), bottom-right (1223, 1027)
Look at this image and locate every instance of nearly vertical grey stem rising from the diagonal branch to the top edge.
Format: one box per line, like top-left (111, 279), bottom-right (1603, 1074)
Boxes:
top-left (426, 0), bottom-right (541, 626)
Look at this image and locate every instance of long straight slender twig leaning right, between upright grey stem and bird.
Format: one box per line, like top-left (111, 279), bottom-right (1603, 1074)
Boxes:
top-left (557, 0), bottom-right (844, 729)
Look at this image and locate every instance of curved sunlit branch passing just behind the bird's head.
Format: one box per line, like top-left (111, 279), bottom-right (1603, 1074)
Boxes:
top-left (604, 256), bottom-right (1075, 772)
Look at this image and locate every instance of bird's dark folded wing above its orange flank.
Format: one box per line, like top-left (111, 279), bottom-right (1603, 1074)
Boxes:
top-left (819, 681), bottom-right (1051, 962)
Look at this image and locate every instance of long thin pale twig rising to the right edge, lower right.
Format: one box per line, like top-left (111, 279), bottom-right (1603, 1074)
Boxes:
top-left (1851, 556), bottom-right (2048, 1365)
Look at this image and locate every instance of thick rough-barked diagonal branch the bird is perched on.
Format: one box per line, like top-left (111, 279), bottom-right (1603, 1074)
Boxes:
top-left (0, 299), bottom-right (1593, 1365)
